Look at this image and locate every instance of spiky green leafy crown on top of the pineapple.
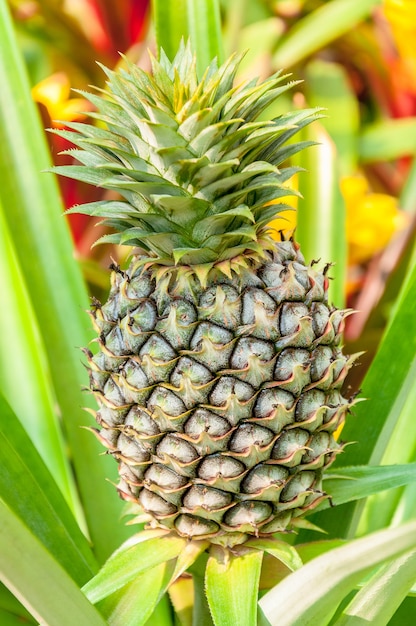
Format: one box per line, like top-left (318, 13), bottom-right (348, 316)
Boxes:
top-left (53, 44), bottom-right (318, 274)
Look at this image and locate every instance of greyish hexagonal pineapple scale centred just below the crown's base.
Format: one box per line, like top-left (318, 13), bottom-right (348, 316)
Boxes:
top-left (198, 284), bottom-right (242, 330)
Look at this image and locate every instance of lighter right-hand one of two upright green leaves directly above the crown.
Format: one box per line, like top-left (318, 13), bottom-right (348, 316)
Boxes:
top-left (187, 0), bottom-right (224, 76)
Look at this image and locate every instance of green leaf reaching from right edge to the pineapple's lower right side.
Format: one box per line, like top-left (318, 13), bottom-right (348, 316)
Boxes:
top-left (320, 463), bottom-right (416, 509)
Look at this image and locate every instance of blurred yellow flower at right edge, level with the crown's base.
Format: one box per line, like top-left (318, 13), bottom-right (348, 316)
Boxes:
top-left (341, 174), bottom-right (405, 265)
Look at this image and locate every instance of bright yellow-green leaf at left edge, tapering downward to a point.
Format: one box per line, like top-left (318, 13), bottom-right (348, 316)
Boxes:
top-left (0, 206), bottom-right (77, 510)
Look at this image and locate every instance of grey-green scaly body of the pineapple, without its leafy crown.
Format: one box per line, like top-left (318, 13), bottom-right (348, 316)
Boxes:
top-left (86, 236), bottom-right (354, 541)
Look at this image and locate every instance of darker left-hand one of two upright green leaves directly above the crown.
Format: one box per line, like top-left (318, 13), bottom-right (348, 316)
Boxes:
top-left (152, 0), bottom-right (188, 60)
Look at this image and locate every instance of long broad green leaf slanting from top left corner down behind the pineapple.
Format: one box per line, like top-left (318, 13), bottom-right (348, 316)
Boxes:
top-left (0, 0), bottom-right (128, 559)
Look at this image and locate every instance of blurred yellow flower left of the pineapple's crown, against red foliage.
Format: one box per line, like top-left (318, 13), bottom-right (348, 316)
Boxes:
top-left (32, 72), bottom-right (92, 126)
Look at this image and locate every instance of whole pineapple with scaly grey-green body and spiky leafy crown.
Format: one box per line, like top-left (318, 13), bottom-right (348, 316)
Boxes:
top-left (55, 46), bottom-right (353, 545)
